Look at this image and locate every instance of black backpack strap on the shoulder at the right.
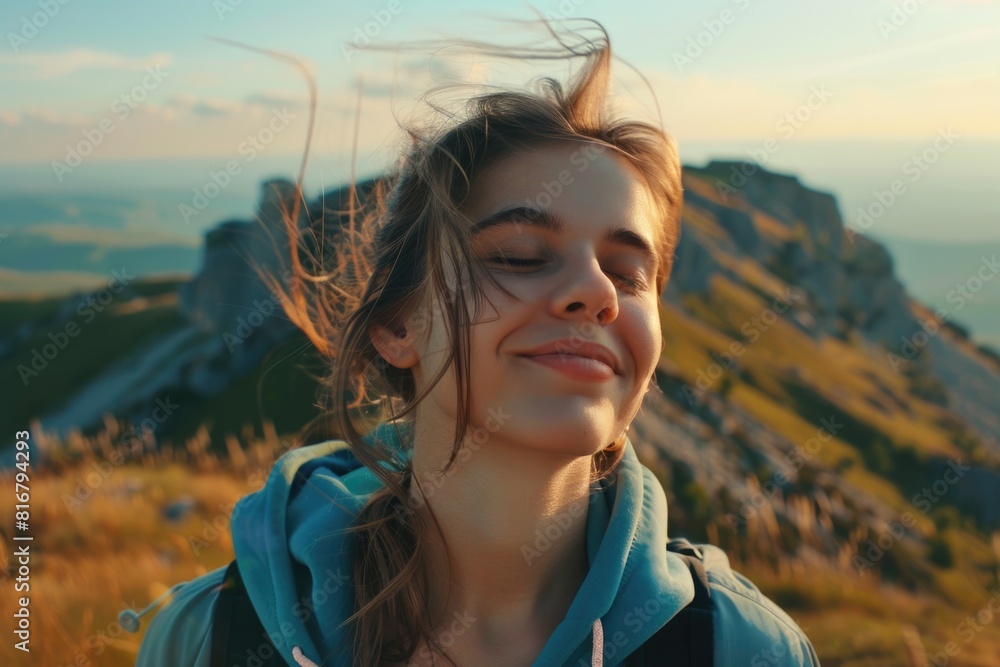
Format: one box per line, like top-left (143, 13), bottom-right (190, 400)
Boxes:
top-left (627, 539), bottom-right (715, 667)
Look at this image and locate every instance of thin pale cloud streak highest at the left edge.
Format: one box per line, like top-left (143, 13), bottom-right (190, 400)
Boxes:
top-left (0, 49), bottom-right (174, 79)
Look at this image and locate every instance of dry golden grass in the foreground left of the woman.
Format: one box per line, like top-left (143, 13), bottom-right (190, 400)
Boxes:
top-left (0, 422), bottom-right (283, 667)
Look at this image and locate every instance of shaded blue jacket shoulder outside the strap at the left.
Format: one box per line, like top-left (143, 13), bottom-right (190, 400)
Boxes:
top-left (135, 564), bottom-right (228, 667)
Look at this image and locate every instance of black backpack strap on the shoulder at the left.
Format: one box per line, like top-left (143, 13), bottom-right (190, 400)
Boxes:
top-left (210, 559), bottom-right (287, 667)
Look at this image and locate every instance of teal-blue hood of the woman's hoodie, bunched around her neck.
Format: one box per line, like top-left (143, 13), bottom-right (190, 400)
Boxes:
top-left (231, 424), bottom-right (694, 667)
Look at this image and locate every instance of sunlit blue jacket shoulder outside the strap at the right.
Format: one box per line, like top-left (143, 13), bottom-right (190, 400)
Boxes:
top-left (695, 544), bottom-right (820, 667)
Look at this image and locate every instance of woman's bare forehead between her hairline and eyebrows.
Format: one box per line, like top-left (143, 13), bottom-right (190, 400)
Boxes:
top-left (462, 140), bottom-right (656, 241)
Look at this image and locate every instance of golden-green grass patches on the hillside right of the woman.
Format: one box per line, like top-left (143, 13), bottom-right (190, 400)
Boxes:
top-left (663, 279), bottom-right (1000, 666)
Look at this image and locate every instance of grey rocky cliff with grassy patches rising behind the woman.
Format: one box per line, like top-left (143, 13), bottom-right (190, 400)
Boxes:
top-left (19, 162), bottom-right (1000, 549)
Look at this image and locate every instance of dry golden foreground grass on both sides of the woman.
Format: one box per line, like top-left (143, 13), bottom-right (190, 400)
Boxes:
top-left (0, 440), bottom-right (1000, 667)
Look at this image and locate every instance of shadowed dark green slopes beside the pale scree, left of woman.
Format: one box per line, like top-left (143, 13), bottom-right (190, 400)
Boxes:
top-left (0, 281), bottom-right (324, 446)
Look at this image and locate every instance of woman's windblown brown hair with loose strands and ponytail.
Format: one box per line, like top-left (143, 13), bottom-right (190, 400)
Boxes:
top-left (265, 17), bottom-right (682, 666)
